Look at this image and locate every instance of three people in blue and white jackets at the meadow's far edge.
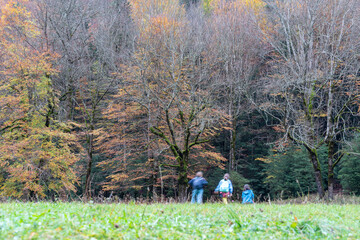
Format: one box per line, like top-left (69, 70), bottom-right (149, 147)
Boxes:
top-left (189, 172), bottom-right (254, 204)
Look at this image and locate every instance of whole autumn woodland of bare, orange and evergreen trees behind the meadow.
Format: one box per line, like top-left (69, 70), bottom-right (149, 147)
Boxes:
top-left (0, 0), bottom-right (360, 201)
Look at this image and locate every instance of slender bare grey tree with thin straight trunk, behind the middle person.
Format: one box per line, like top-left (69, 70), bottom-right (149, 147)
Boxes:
top-left (207, 0), bottom-right (266, 171)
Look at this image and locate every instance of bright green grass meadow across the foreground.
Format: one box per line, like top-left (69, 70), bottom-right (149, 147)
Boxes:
top-left (0, 203), bottom-right (360, 239)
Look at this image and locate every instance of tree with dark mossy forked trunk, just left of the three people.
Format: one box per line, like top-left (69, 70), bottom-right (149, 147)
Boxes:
top-left (126, 0), bottom-right (223, 200)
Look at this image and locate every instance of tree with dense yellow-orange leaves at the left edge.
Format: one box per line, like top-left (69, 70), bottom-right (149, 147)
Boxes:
top-left (0, 0), bottom-right (78, 198)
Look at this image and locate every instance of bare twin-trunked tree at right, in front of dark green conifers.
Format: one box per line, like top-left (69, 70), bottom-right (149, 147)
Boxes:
top-left (264, 0), bottom-right (359, 198)
